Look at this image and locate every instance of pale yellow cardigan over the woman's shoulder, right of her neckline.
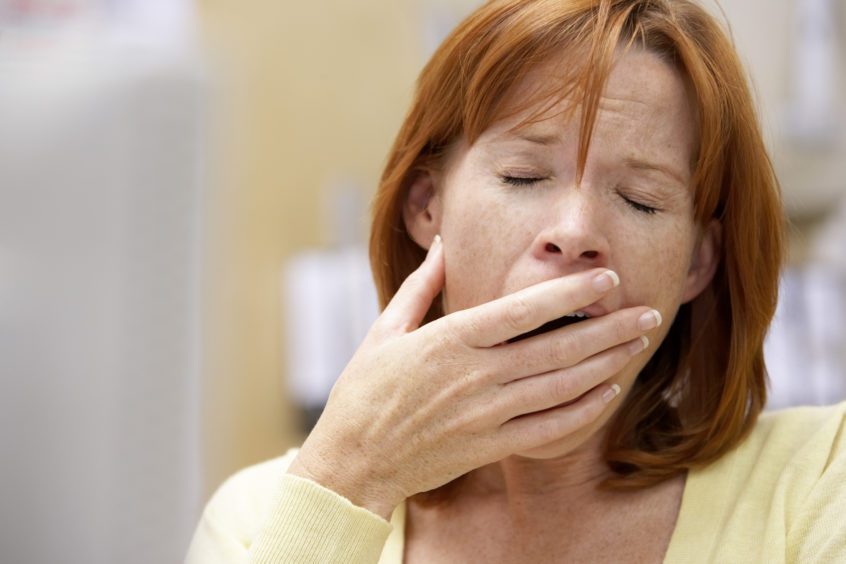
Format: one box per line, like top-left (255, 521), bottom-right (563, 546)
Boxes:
top-left (665, 403), bottom-right (846, 562)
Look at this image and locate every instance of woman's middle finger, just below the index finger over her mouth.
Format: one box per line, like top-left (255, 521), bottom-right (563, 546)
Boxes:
top-left (496, 306), bottom-right (661, 383)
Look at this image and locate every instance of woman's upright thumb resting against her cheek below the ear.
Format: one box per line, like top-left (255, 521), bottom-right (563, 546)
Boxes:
top-left (380, 235), bottom-right (444, 333)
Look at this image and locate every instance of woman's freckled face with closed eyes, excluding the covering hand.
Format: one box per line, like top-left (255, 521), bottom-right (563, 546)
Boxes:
top-left (406, 47), bottom-right (718, 458)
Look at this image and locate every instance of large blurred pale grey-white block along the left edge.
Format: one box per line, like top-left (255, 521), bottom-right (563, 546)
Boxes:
top-left (0, 35), bottom-right (204, 564)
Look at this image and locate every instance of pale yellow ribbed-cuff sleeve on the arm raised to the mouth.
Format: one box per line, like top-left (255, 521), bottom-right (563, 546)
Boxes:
top-left (186, 453), bottom-right (391, 564)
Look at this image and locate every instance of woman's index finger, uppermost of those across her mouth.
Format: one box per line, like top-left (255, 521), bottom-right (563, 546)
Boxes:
top-left (454, 268), bottom-right (620, 347)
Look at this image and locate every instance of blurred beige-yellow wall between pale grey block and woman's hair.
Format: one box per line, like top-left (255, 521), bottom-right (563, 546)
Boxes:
top-left (199, 0), bottom-right (480, 495)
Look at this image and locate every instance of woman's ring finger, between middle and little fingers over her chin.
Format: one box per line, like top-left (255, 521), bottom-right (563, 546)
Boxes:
top-left (494, 336), bottom-right (649, 422)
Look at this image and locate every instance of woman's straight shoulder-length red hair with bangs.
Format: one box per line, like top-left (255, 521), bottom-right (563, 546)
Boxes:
top-left (370, 0), bottom-right (784, 494)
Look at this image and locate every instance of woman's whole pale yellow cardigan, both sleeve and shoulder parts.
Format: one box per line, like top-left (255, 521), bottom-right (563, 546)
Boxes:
top-left (186, 403), bottom-right (846, 564)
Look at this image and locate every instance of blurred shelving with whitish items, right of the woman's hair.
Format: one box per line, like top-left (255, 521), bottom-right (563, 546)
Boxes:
top-left (721, 0), bottom-right (846, 409)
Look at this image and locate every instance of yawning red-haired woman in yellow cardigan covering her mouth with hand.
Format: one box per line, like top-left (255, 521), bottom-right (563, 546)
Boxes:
top-left (189, 0), bottom-right (846, 563)
